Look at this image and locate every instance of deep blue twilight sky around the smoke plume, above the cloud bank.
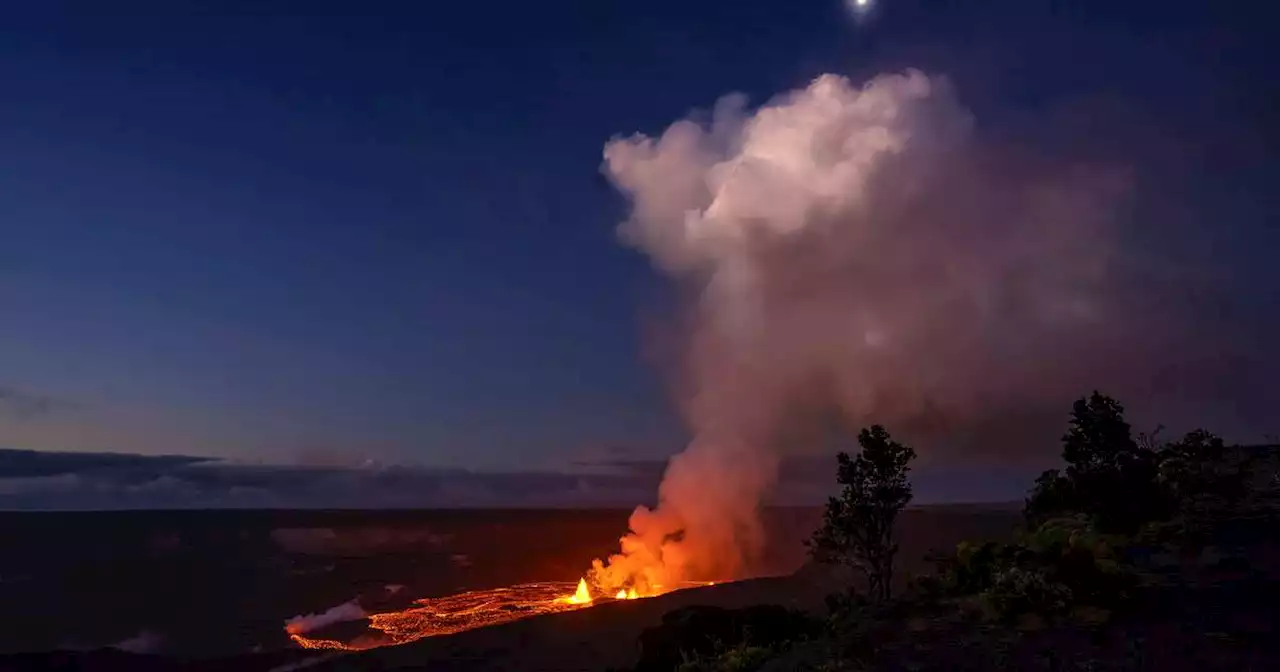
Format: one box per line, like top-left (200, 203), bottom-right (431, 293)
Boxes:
top-left (0, 0), bottom-right (1280, 468)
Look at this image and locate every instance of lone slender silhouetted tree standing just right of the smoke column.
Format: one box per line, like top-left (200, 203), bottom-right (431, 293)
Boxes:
top-left (809, 425), bottom-right (915, 600)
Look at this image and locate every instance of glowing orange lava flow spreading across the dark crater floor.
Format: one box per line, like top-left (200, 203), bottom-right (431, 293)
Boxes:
top-left (285, 579), bottom-right (708, 652)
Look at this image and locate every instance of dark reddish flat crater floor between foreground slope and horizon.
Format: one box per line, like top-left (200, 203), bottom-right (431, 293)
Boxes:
top-left (0, 506), bottom-right (1016, 669)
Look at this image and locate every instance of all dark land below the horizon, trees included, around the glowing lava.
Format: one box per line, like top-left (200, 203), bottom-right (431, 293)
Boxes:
top-left (0, 392), bottom-right (1280, 672)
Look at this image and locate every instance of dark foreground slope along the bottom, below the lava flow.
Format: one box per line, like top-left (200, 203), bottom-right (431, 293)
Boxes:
top-left (0, 514), bottom-right (1280, 672)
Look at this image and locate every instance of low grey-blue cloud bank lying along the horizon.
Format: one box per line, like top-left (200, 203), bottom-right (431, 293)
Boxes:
top-left (0, 448), bottom-right (1036, 511)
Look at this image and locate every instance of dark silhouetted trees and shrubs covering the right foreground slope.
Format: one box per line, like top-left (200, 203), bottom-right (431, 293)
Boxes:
top-left (640, 392), bottom-right (1280, 672)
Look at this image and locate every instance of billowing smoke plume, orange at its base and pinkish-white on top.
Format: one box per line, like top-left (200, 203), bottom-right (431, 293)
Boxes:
top-left (593, 70), bottom-right (1254, 593)
